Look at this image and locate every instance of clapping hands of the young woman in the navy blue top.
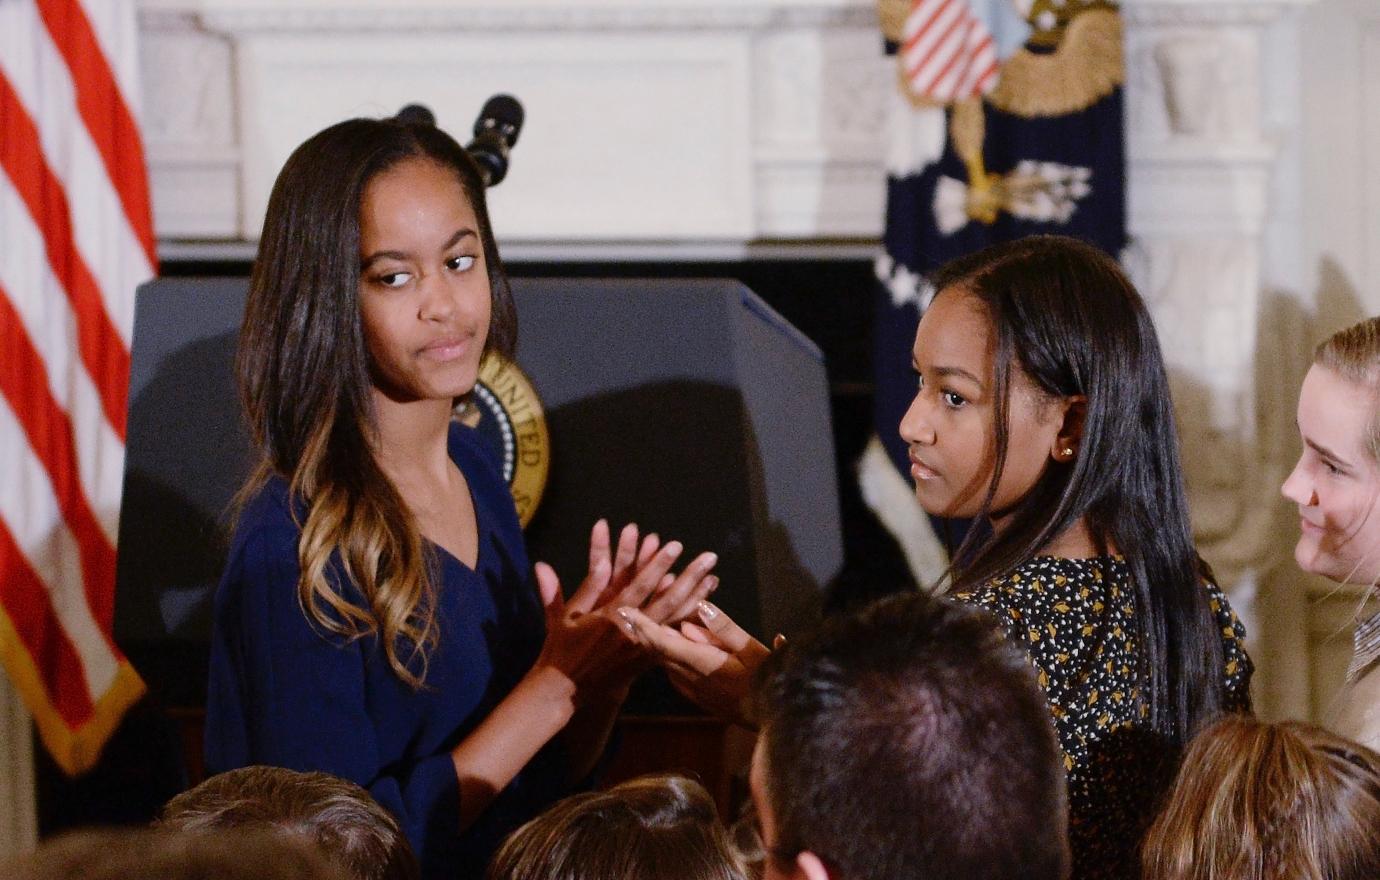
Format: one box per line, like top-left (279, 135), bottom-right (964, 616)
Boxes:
top-left (535, 520), bottom-right (719, 703)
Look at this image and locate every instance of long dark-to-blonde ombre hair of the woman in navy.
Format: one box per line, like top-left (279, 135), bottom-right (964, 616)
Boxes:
top-left (235, 119), bottom-right (516, 687)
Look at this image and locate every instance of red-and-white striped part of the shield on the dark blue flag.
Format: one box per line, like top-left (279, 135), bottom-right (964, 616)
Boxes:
top-left (900, 0), bottom-right (998, 103)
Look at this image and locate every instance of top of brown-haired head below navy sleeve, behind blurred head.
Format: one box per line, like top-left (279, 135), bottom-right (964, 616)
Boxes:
top-left (159, 767), bottom-right (418, 880)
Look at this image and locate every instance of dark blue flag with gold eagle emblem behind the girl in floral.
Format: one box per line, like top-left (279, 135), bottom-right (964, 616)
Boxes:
top-left (860, 0), bottom-right (1126, 582)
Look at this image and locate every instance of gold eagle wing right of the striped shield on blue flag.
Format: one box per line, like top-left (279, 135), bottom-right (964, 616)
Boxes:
top-left (987, 8), bottom-right (1126, 117)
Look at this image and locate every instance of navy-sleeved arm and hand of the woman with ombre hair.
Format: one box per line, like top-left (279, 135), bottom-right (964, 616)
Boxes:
top-left (206, 510), bottom-right (717, 848)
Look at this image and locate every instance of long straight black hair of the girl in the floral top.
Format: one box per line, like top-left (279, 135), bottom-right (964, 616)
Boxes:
top-left (932, 236), bottom-right (1224, 745)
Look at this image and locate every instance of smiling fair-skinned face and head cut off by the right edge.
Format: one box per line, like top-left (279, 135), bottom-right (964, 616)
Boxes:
top-left (1282, 317), bottom-right (1380, 583)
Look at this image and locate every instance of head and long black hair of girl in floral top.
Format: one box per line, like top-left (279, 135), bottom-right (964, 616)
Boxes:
top-left (901, 236), bottom-right (1223, 742)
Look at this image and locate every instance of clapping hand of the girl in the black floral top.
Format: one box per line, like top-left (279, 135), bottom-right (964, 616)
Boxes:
top-left (618, 601), bottom-right (771, 728)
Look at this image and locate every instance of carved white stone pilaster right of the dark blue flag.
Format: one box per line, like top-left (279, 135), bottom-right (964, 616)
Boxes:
top-left (1123, 0), bottom-right (1317, 714)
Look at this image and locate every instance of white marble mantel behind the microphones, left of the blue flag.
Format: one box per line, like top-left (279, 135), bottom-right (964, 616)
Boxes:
top-left (142, 0), bottom-right (890, 243)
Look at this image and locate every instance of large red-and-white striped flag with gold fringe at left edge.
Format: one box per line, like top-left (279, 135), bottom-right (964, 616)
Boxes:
top-left (0, 0), bottom-right (156, 774)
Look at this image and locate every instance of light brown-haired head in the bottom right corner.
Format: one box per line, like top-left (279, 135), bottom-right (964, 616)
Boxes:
top-left (1141, 716), bottom-right (1380, 880)
